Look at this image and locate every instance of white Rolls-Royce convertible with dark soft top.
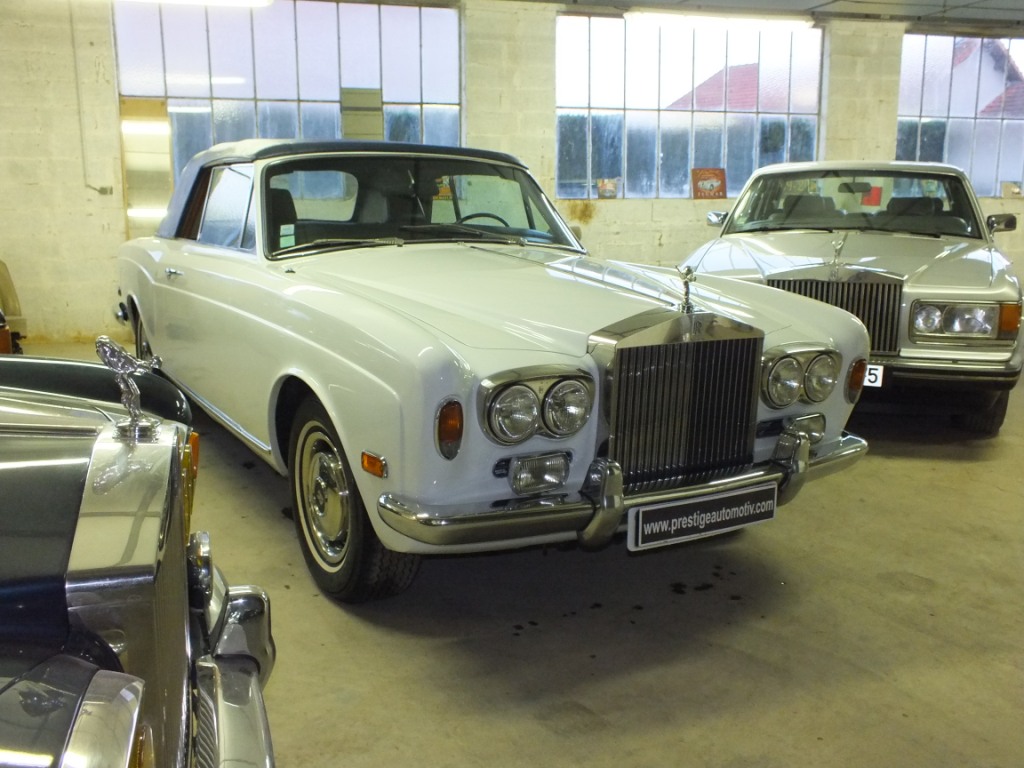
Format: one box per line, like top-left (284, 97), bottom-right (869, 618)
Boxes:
top-left (118, 140), bottom-right (868, 601)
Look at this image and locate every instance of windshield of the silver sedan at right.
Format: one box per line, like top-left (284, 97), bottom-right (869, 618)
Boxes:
top-left (724, 171), bottom-right (982, 238)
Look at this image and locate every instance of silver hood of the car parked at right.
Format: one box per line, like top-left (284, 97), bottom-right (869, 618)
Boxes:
top-left (686, 230), bottom-right (1009, 287)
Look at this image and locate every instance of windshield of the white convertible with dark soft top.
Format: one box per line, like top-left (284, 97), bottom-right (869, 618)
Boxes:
top-left (263, 154), bottom-right (582, 257)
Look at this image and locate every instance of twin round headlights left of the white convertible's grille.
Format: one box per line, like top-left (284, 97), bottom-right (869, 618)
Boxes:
top-left (481, 374), bottom-right (594, 445)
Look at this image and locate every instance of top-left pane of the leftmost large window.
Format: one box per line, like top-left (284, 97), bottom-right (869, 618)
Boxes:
top-left (114, 2), bottom-right (165, 97)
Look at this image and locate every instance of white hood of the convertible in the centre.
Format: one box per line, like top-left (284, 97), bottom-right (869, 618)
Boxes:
top-left (285, 243), bottom-right (680, 354)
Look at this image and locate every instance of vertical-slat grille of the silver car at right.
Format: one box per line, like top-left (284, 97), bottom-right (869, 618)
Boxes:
top-left (768, 280), bottom-right (903, 354)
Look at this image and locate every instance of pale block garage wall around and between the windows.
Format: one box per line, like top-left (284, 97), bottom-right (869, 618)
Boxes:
top-left (0, 0), bottom-right (1024, 342)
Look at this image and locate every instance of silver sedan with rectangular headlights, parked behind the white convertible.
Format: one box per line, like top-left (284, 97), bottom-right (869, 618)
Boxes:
top-left (683, 162), bottom-right (1024, 435)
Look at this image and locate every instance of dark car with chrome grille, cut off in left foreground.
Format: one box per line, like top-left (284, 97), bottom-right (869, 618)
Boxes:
top-left (0, 339), bottom-right (275, 768)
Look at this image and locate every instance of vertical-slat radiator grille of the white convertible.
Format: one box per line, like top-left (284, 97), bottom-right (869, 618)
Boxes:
top-left (609, 338), bottom-right (763, 494)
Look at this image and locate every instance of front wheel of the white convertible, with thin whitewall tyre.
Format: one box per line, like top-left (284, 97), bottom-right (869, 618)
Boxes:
top-left (289, 397), bottom-right (420, 603)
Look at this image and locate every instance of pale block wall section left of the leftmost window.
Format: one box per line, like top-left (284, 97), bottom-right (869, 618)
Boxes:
top-left (0, 0), bottom-right (125, 340)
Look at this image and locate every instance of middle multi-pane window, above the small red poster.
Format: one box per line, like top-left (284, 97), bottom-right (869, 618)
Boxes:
top-left (556, 13), bottom-right (821, 198)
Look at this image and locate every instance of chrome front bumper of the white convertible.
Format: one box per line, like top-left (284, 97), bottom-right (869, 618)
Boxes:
top-left (377, 431), bottom-right (867, 547)
